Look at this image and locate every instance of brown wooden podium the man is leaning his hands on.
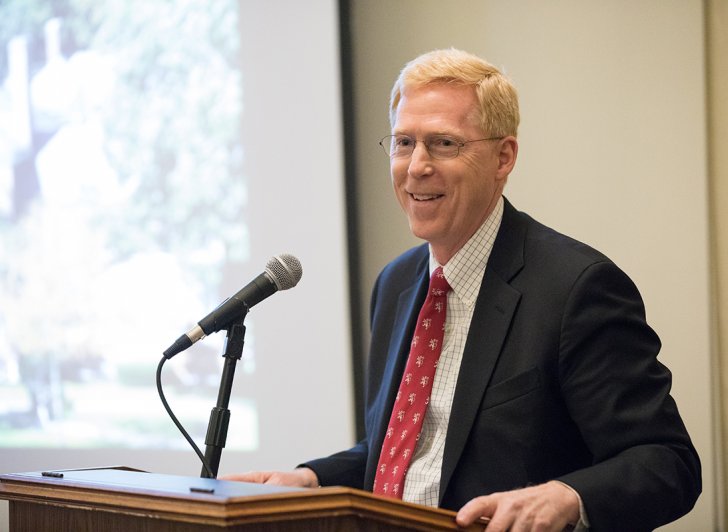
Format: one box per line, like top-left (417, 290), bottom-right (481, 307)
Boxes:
top-left (0, 467), bottom-right (483, 532)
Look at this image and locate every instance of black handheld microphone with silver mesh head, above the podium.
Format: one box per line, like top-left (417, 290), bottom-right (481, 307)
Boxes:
top-left (164, 253), bottom-right (303, 359)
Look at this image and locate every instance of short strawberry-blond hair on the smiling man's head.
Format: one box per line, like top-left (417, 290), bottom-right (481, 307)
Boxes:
top-left (389, 48), bottom-right (520, 137)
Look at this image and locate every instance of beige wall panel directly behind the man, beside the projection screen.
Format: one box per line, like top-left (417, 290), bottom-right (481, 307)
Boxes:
top-left (352, 0), bottom-right (716, 531)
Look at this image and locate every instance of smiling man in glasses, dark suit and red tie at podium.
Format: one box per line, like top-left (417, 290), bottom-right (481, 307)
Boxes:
top-left (229, 50), bottom-right (701, 532)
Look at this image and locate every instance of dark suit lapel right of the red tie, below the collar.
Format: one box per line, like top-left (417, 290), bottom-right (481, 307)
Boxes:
top-left (440, 200), bottom-right (526, 502)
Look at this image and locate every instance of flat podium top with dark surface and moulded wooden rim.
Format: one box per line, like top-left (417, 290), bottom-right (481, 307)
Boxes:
top-left (0, 467), bottom-right (483, 531)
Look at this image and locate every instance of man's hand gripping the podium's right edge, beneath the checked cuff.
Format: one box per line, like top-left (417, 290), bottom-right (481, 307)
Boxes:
top-left (456, 481), bottom-right (579, 532)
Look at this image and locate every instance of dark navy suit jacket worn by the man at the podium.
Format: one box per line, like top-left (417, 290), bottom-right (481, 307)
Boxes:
top-left (306, 197), bottom-right (701, 531)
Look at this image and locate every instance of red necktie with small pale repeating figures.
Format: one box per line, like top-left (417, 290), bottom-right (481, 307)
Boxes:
top-left (373, 268), bottom-right (450, 499)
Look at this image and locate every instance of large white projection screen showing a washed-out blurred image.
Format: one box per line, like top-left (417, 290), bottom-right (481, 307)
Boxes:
top-left (0, 0), bottom-right (354, 476)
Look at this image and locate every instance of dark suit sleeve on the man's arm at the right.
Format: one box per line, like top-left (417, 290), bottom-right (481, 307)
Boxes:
top-left (559, 262), bottom-right (701, 530)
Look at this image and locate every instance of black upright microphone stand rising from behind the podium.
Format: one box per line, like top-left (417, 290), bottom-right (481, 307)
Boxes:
top-left (200, 305), bottom-right (248, 478)
